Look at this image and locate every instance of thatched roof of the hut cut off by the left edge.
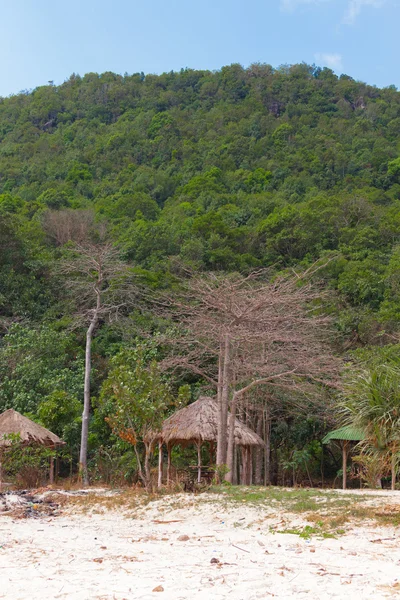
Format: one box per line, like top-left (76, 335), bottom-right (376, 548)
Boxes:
top-left (0, 408), bottom-right (65, 446)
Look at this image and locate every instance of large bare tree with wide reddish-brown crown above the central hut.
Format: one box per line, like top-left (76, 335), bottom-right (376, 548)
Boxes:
top-left (159, 271), bottom-right (338, 479)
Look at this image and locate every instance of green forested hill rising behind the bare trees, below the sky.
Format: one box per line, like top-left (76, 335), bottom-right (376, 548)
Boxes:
top-left (0, 64), bottom-right (400, 338)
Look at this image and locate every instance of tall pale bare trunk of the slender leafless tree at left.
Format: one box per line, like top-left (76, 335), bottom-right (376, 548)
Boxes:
top-left (79, 308), bottom-right (100, 486)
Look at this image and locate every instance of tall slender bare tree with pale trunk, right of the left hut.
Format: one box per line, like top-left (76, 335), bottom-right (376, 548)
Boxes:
top-left (46, 211), bottom-right (136, 485)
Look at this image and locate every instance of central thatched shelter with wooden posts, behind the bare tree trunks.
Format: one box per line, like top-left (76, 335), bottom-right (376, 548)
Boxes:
top-left (158, 396), bottom-right (265, 483)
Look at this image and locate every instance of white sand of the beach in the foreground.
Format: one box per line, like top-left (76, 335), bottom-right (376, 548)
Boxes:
top-left (0, 493), bottom-right (400, 600)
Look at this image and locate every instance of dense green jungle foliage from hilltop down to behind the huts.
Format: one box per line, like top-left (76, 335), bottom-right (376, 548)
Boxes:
top-left (0, 64), bottom-right (400, 488)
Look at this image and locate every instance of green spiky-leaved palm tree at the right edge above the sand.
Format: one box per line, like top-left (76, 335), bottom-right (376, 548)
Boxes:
top-left (341, 365), bottom-right (400, 489)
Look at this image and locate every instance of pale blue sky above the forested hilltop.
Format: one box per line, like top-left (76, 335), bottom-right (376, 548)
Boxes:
top-left (0, 0), bottom-right (400, 96)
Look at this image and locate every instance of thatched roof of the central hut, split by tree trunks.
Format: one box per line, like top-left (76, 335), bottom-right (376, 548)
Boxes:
top-left (161, 396), bottom-right (265, 446)
